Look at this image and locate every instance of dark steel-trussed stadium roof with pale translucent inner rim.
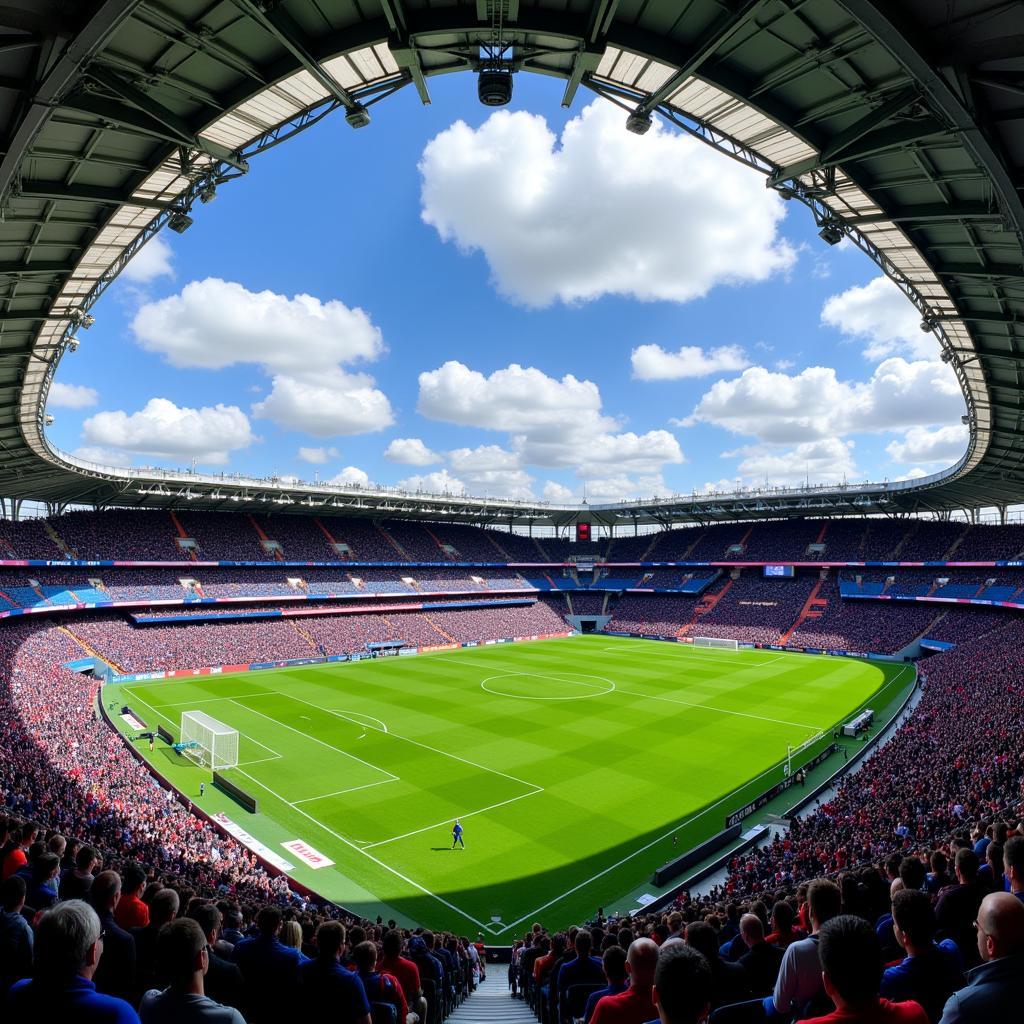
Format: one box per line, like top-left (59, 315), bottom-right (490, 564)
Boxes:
top-left (0, 0), bottom-right (1024, 522)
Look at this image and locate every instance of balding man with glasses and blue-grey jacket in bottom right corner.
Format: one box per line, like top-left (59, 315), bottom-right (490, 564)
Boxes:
top-left (941, 893), bottom-right (1024, 1024)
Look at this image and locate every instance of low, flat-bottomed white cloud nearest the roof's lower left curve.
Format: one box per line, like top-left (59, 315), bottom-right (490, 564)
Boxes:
top-left (82, 398), bottom-right (256, 465)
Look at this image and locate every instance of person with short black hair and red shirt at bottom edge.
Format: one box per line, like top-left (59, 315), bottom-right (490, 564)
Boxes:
top-left (806, 917), bottom-right (928, 1024)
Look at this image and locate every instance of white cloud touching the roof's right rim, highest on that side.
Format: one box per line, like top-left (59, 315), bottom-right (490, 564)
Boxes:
top-left (821, 276), bottom-right (938, 359)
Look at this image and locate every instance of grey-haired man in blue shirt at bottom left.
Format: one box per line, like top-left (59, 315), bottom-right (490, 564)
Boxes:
top-left (5, 900), bottom-right (139, 1024)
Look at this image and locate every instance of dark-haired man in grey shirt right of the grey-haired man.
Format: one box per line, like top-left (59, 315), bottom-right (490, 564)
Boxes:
top-left (138, 918), bottom-right (246, 1024)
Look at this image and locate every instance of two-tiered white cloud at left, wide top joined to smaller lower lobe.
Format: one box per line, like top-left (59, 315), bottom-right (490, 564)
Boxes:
top-left (132, 278), bottom-right (393, 437)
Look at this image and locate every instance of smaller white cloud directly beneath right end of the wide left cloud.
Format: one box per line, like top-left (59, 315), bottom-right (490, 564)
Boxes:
top-left (253, 370), bottom-right (394, 437)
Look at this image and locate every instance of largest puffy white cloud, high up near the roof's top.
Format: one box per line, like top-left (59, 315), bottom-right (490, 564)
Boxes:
top-left (420, 100), bottom-right (796, 307)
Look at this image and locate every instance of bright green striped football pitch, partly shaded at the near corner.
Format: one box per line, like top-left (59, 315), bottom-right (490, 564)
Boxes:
top-left (103, 636), bottom-right (912, 939)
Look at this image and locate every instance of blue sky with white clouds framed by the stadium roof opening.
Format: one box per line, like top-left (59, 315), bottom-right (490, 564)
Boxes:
top-left (41, 74), bottom-right (967, 501)
